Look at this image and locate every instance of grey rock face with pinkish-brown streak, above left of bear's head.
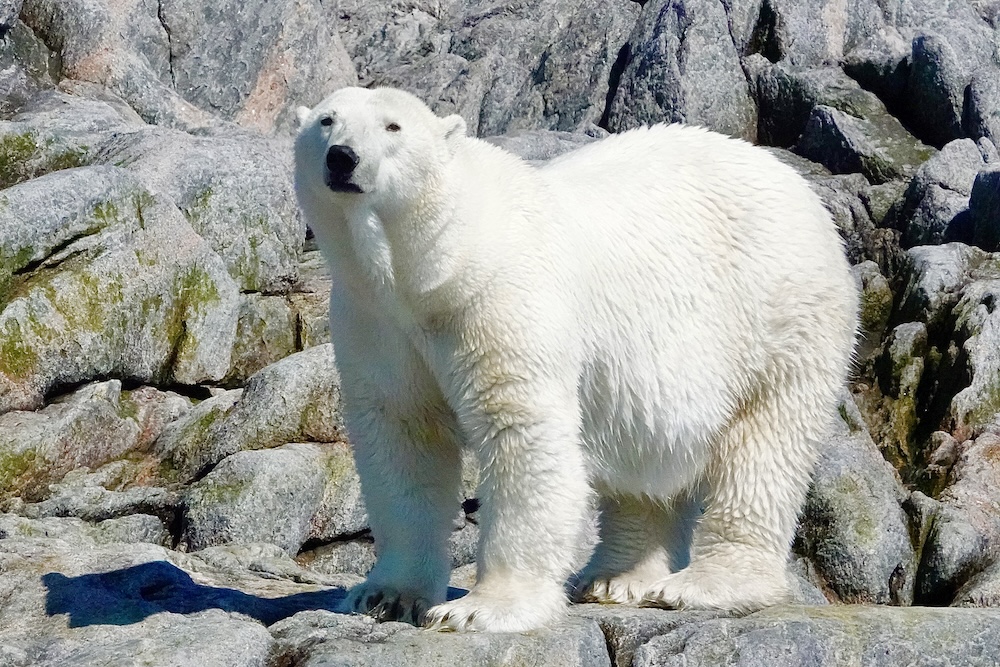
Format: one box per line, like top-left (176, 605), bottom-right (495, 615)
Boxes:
top-left (158, 0), bottom-right (357, 133)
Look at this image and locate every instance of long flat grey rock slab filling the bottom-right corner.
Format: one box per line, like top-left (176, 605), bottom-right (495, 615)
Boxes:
top-left (632, 605), bottom-right (1000, 667)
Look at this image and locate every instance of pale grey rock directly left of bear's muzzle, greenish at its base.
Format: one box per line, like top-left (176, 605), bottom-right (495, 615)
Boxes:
top-left (95, 129), bottom-right (304, 292)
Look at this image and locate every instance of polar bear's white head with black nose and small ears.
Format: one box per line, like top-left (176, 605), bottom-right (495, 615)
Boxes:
top-left (295, 88), bottom-right (465, 211)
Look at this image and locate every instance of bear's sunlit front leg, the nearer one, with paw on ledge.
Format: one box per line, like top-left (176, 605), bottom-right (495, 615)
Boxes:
top-left (427, 382), bottom-right (590, 632)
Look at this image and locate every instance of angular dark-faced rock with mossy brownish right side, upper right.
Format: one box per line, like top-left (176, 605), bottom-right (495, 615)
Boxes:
top-left (795, 105), bottom-right (933, 183)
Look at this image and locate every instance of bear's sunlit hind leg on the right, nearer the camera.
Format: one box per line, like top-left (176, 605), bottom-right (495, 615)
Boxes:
top-left (644, 382), bottom-right (833, 613)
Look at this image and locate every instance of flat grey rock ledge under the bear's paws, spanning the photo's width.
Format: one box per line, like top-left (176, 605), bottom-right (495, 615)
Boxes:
top-left (0, 528), bottom-right (1000, 667)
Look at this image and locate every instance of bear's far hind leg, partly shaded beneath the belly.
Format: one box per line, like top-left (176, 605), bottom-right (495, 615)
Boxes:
top-left (573, 494), bottom-right (698, 604)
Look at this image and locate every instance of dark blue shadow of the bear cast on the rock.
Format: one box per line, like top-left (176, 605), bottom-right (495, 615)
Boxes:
top-left (42, 561), bottom-right (466, 628)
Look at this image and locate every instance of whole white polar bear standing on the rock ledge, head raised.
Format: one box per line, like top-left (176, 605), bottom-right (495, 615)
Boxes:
top-left (295, 88), bottom-right (857, 631)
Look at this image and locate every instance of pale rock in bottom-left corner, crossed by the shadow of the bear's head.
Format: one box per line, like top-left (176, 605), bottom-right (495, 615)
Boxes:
top-left (0, 536), bottom-right (272, 667)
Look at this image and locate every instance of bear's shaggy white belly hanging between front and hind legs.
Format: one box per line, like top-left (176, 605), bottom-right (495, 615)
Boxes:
top-left (579, 365), bottom-right (726, 499)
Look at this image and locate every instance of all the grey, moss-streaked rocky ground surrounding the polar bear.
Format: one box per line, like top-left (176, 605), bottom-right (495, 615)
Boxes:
top-left (0, 0), bottom-right (1000, 667)
